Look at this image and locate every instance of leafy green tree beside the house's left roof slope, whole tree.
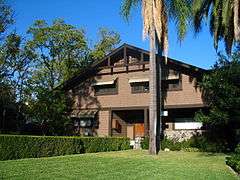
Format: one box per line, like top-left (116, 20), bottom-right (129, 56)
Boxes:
top-left (25, 19), bottom-right (120, 135)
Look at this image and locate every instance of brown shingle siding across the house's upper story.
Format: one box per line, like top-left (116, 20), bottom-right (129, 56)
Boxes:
top-left (70, 66), bottom-right (203, 109)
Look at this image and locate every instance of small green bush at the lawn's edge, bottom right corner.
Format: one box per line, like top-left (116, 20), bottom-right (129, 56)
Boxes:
top-left (226, 144), bottom-right (240, 174)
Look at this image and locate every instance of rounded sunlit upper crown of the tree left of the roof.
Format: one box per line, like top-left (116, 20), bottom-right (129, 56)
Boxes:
top-left (27, 19), bottom-right (87, 86)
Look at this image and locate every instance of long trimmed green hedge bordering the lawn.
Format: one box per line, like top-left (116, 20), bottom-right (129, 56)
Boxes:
top-left (0, 135), bottom-right (130, 160)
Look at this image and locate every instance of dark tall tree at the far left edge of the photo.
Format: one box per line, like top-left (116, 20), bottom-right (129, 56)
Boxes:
top-left (0, 0), bottom-right (30, 130)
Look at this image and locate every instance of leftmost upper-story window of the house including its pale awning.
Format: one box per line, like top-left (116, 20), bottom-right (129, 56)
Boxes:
top-left (93, 80), bottom-right (118, 95)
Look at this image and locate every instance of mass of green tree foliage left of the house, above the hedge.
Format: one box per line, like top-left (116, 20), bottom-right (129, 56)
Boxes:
top-left (0, 4), bottom-right (120, 135)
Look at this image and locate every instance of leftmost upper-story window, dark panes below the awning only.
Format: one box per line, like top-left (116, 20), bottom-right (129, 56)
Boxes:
top-left (94, 82), bottom-right (118, 95)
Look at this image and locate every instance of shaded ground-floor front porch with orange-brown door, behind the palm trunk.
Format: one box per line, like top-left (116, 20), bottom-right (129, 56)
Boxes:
top-left (109, 108), bottom-right (204, 141)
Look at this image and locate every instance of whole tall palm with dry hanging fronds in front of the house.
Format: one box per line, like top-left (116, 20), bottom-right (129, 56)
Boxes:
top-left (121, 0), bottom-right (191, 154)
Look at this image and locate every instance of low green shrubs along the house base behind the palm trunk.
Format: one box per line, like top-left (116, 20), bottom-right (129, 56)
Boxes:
top-left (141, 136), bottom-right (226, 152)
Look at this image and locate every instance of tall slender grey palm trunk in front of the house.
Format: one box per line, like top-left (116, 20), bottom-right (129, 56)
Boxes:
top-left (149, 25), bottom-right (160, 155)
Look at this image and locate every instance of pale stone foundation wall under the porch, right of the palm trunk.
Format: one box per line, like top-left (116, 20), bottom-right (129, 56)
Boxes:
top-left (164, 130), bottom-right (203, 142)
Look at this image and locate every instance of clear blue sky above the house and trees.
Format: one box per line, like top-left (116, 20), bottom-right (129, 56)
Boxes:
top-left (8, 0), bottom-right (222, 68)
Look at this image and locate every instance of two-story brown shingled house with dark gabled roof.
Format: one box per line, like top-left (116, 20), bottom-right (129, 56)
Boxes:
top-left (63, 44), bottom-right (206, 139)
